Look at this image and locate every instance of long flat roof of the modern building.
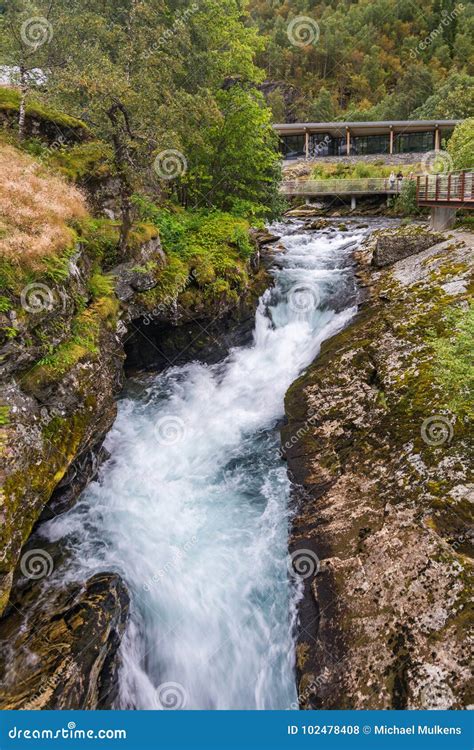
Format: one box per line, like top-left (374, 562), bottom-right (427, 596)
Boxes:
top-left (273, 120), bottom-right (461, 135)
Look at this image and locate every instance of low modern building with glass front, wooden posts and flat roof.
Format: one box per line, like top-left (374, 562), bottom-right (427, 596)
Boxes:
top-left (273, 120), bottom-right (459, 159)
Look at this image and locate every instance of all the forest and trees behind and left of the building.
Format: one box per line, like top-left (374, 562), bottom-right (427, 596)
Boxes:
top-left (0, 0), bottom-right (474, 231)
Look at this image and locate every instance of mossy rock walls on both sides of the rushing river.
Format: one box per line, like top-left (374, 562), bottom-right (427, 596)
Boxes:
top-left (0, 129), bottom-right (472, 709)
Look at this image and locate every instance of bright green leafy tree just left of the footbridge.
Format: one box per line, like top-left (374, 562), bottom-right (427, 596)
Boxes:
top-left (160, 84), bottom-right (280, 217)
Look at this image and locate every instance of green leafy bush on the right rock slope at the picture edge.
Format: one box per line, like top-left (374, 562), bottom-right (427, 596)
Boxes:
top-left (433, 303), bottom-right (474, 420)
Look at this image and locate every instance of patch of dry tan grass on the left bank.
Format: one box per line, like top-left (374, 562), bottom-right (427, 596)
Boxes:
top-left (0, 144), bottom-right (87, 265)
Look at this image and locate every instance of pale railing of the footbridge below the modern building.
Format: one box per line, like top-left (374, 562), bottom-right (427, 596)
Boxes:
top-left (280, 177), bottom-right (402, 195)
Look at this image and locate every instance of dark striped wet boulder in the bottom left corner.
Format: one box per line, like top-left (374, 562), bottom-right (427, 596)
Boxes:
top-left (0, 574), bottom-right (129, 710)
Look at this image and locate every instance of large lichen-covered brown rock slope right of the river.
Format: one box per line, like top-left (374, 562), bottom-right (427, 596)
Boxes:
top-left (282, 233), bottom-right (474, 709)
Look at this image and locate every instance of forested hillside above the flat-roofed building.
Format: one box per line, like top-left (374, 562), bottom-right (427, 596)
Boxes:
top-left (250, 0), bottom-right (474, 122)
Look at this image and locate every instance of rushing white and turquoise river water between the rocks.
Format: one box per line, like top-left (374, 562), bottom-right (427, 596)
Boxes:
top-left (43, 217), bottom-right (364, 709)
